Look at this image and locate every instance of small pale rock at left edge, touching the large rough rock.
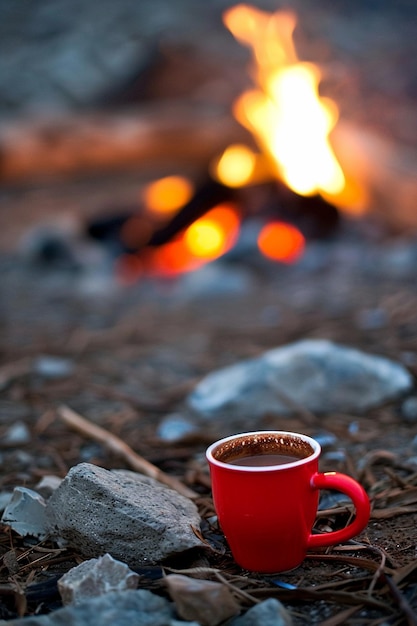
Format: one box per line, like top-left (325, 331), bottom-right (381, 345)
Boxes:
top-left (1, 487), bottom-right (48, 540)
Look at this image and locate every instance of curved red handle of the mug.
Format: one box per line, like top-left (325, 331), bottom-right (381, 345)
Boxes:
top-left (308, 472), bottom-right (371, 548)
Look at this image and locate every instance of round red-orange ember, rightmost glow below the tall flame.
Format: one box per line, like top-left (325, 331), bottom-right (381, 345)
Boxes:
top-left (258, 222), bottom-right (305, 263)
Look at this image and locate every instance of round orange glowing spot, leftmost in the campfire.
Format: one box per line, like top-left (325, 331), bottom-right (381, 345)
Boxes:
top-left (143, 176), bottom-right (194, 217)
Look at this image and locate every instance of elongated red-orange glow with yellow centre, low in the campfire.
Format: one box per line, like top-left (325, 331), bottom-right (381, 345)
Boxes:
top-left (147, 203), bottom-right (240, 276)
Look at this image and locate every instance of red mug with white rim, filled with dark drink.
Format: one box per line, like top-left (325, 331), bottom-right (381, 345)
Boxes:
top-left (206, 431), bottom-right (370, 573)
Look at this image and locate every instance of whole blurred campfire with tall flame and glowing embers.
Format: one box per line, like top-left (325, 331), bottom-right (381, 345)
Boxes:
top-left (109, 4), bottom-right (376, 280)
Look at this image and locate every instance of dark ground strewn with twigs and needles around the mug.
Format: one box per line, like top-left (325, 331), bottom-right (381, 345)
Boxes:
top-left (0, 180), bottom-right (417, 625)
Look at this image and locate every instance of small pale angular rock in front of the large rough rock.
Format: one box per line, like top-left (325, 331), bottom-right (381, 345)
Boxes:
top-left (58, 554), bottom-right (139, 604)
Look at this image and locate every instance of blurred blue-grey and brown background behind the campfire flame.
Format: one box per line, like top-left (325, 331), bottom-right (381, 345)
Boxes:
top-left (0, 0), bottom-right (417, 258)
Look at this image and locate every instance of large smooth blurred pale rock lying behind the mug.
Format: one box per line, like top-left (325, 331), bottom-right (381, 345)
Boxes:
top-left (188, 340), bottom-right (413, 425)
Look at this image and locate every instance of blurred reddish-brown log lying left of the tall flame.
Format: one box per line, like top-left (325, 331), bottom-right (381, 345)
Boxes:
top-left (0, 103), bottom-right (242, 184)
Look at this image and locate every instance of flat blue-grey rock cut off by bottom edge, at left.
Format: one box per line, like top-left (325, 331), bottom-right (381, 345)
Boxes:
top-left (0, 589), bottom-right (199, 626)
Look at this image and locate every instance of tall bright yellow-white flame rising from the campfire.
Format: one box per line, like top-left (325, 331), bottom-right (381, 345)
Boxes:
top-left (223, 4), bottom-right (365, 213)
